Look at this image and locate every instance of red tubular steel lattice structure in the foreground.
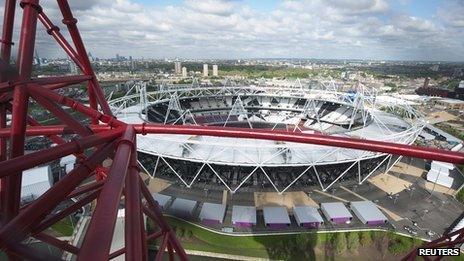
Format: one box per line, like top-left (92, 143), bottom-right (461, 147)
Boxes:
top-left (0, 0), bottom-right (464, 260)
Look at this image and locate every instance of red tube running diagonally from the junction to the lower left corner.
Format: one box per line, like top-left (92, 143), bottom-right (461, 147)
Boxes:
top-left (0, 142), bottom-right (115, 249)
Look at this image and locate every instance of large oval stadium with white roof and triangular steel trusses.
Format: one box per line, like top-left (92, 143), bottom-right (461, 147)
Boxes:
top-left (110, 83), bottom-right (425, 193)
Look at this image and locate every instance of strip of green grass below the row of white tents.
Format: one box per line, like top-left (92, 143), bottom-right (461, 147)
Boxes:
top-left (148, 214), bottom-right (422, 260)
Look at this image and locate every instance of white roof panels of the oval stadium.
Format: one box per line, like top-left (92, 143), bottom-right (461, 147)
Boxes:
top-left (132, 108), bottom-right (410, 166)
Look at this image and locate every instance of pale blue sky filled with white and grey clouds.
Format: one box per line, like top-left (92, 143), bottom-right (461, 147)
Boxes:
top-left (0, 0), bottom-right (464, 61)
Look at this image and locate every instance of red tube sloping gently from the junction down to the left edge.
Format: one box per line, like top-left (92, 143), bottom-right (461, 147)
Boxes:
top-left (0, 129), bottom-right (121, 177)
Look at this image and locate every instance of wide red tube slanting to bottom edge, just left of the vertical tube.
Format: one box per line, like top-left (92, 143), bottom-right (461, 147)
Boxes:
top-left (78, 126), bottom-right (136, 260)
